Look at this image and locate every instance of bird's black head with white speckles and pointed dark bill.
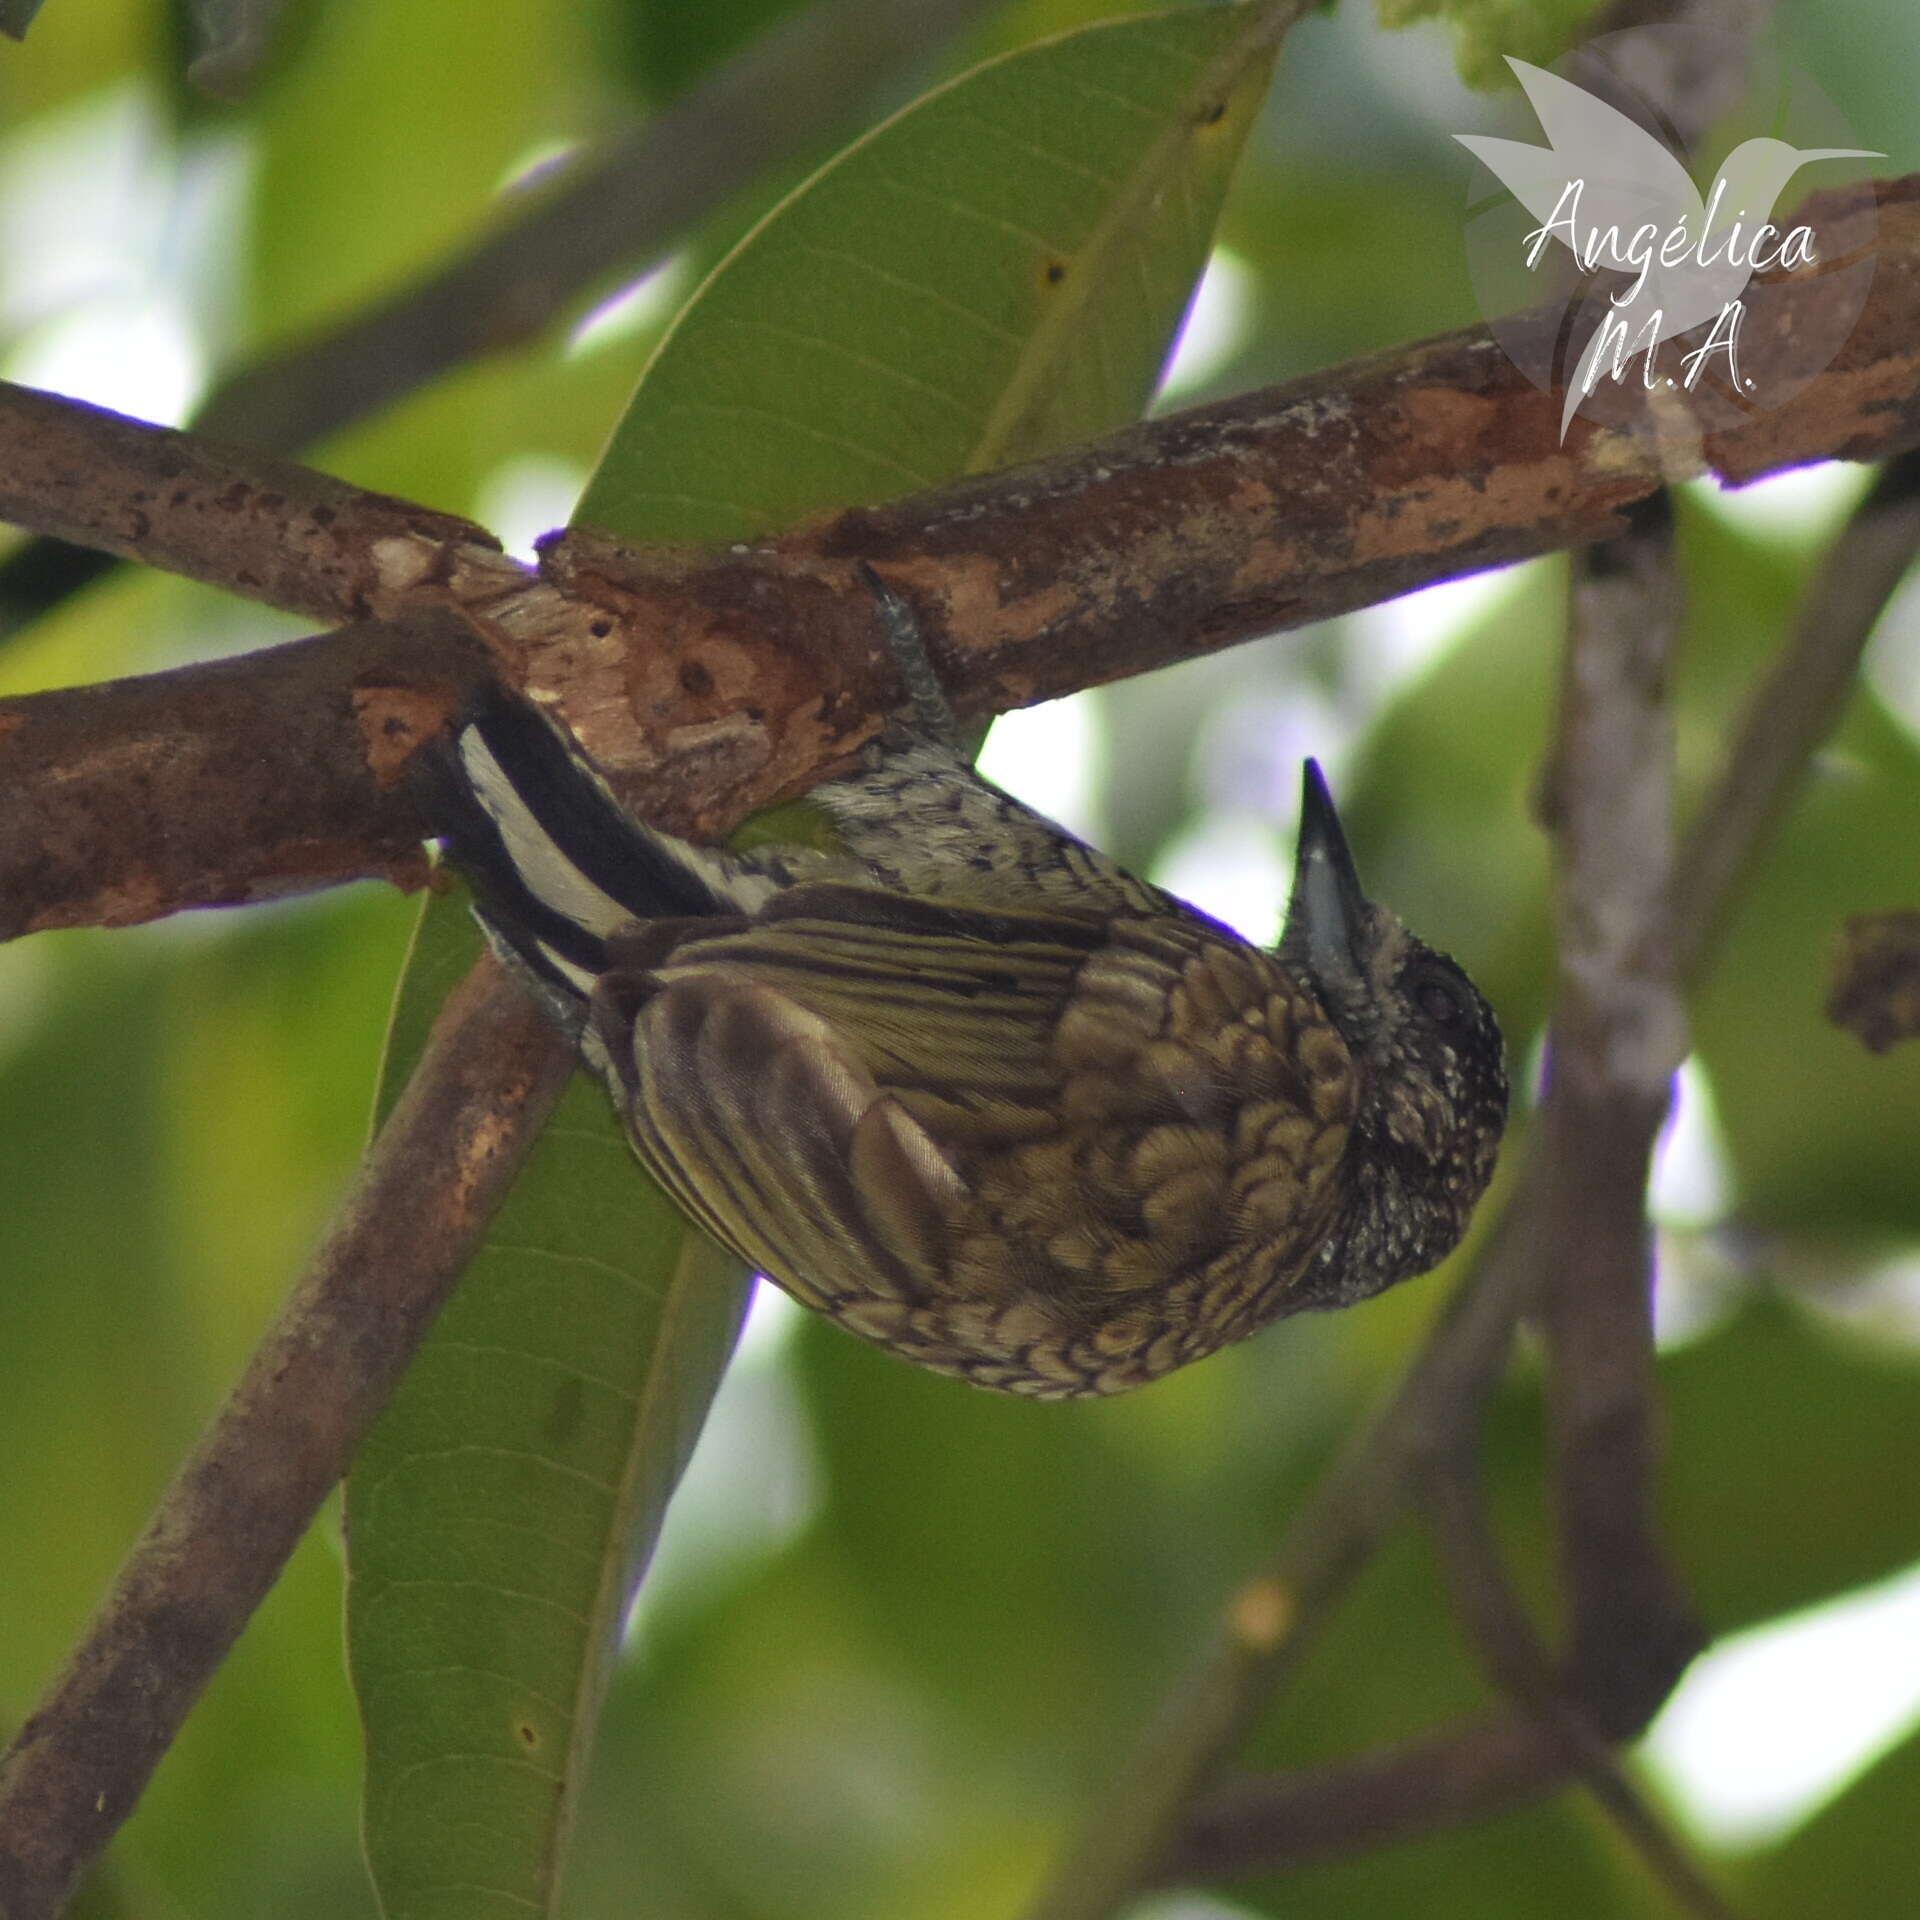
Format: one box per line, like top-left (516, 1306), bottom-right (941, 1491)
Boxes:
top-left (1281, 760), bottom-right (1507, 1306)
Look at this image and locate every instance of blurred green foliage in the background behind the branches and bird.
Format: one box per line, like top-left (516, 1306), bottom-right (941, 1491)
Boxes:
top-left (0, 0), bottom-right (1920, 1920)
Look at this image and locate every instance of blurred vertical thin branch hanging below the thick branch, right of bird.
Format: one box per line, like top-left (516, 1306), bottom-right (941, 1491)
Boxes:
top-left (1540, 495), bottom-right (1705, 1740)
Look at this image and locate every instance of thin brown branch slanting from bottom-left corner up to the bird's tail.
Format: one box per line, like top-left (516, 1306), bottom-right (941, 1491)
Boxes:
top-left (0, 962), bottom-right (572, 1920)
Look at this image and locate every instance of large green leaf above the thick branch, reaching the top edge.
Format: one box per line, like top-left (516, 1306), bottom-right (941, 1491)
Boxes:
top-left (576, 8), bottom-right (1277, 541)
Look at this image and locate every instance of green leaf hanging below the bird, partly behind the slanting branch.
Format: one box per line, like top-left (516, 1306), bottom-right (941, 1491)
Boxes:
top-left (348, 897), bottom-right (747, 1916)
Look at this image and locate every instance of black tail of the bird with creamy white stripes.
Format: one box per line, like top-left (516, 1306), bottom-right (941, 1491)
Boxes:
top-left (411, 685), bottom-right (730, 1018)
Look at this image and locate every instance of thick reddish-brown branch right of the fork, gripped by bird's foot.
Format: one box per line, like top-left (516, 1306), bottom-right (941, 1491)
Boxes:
top-left (520, 177), bottom-right (1920, 817)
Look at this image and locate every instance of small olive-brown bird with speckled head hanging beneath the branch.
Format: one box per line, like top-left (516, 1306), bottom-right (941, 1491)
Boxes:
top-left (411, 570), bottom-right (1507, 1400)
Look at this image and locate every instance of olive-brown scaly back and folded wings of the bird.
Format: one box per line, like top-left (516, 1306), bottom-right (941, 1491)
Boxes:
top-left (595, 883), bottom-right (1356, 1317)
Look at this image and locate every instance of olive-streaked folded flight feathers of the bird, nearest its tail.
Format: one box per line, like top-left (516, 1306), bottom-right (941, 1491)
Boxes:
top-left (595, 883), bottom-right (1102, 1306)
